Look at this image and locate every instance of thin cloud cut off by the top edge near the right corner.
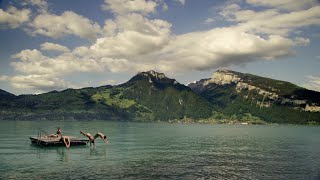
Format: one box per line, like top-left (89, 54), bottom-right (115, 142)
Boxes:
top-left (246, 0), bottom-right (319, 11)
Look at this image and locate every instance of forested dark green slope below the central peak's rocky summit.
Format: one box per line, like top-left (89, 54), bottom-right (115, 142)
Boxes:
top-left (120, 80), bottom-right (211, 120)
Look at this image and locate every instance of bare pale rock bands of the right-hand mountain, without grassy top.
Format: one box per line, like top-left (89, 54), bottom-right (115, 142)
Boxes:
top-left (189, 69), bottom-right (320, 112)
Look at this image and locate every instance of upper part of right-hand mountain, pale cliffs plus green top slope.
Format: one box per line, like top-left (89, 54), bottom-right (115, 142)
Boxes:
top-left (189, 69), bottom-right (320, 112)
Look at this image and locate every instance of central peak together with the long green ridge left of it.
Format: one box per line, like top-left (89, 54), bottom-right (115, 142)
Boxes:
top-left (0, 71), bottom-right (212, 121)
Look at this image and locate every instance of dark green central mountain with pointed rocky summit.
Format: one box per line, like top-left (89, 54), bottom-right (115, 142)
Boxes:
top-left (114, 71), bottom-right (212, 120)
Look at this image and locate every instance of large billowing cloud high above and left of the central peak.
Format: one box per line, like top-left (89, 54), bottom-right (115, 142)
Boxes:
top-left (94, 13), bottom-right (171, 58)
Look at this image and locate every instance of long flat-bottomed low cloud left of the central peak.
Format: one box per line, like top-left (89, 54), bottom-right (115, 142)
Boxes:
top-left (11, 48), bottom-right (133, 77)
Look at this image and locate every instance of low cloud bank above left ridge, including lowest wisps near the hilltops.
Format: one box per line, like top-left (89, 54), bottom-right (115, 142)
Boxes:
top-left (7, 49), bottom-right (135, 92)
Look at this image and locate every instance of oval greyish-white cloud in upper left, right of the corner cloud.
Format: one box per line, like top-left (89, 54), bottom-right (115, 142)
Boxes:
top-left (30, 11), bottom-right (101, 40)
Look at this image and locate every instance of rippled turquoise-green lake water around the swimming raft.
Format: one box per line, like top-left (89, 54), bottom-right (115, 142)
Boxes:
top-left (0, 121), bottom-right (320, 179)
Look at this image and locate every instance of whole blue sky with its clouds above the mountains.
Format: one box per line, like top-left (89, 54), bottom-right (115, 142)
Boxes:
top-left (0, 0), bottom-right (320, 95)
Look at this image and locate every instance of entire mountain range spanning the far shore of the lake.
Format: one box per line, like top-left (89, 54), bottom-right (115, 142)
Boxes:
top-left (0, 69), bottom-right (320, 124)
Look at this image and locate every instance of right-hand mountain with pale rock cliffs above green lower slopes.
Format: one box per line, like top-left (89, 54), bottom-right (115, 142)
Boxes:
top-left (188, 69), bottom-right (320, 124)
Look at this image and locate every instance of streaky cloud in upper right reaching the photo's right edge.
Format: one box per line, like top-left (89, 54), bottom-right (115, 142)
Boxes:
top-left (220, 4), bottom-right (320, 35)
